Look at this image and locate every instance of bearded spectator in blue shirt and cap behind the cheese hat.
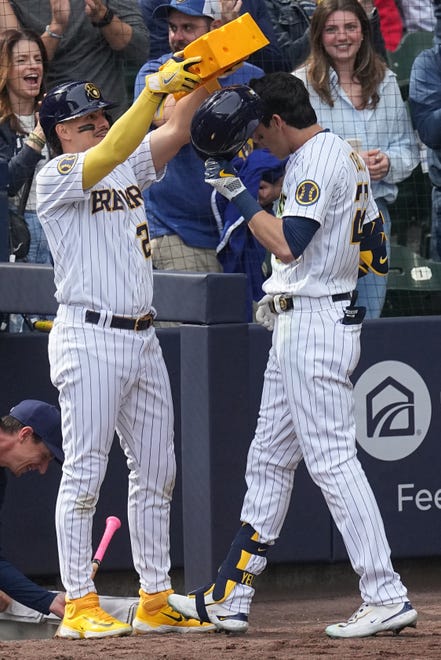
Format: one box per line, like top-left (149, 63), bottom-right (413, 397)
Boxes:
top-left (134, 0), bottom-right (263, 272)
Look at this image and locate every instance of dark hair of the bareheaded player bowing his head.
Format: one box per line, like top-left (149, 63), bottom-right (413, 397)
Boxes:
top-left (249, 71), bottom-right (317, 129)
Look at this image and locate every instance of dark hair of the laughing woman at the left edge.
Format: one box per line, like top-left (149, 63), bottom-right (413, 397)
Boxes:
top-left (0, 29), bottom-right (48, 133)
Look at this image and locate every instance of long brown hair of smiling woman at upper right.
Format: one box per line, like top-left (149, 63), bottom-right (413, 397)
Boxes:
top-left (308, 0), bottom-right (386, 109)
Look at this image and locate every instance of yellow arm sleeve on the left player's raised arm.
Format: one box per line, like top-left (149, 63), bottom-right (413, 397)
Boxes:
top-left (83, 89), bottom-right (162, 190)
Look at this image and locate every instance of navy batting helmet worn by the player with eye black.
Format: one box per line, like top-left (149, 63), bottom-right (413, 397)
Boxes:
top-left (39, 80), bottom-right (115, 143)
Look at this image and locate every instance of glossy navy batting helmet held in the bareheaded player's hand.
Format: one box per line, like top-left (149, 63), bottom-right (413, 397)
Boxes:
top-left (191, 85), bottom-right (262, 160)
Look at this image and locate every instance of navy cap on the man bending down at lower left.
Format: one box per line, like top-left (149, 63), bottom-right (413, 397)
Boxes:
top-left (9, 399), bottom-right (64, 464)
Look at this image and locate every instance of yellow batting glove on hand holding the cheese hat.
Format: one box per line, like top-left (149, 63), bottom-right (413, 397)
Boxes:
top-left (145, 53), bottom-right (202, 94)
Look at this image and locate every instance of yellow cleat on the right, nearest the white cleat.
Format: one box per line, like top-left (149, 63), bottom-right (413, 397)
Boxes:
top-left (132, 589), bottom-right (216, 635)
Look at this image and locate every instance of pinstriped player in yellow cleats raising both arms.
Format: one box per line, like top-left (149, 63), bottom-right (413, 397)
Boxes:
top-left (37, 58), bottom-right (214, 639)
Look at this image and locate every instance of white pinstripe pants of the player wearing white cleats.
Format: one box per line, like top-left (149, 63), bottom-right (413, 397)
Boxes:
top-left (241, 298), bottom-right (407, 604)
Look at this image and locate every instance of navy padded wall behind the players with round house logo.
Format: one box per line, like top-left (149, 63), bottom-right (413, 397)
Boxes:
top-left (0, 266), bottom-right (441, 589)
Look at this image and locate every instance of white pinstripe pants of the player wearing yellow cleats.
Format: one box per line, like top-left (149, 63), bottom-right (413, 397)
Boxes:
top-left (49, 306), bottom-right (176, 598)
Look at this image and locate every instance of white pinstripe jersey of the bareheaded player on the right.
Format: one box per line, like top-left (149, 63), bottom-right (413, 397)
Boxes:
top-left (263, 131), bottom-right (378, 298)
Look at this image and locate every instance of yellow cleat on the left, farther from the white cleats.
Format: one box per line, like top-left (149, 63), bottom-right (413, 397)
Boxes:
top-left (55, 592), bottom-right (132, 639)
